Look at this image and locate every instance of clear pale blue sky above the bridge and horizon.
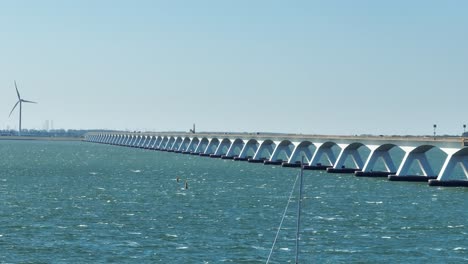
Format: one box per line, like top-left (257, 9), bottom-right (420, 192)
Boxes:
top-left (0, 0), bottom-right (468, 135)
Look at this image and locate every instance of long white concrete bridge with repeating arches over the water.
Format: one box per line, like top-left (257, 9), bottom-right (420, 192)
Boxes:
top-left (85, 132), bottom-right (468, 187)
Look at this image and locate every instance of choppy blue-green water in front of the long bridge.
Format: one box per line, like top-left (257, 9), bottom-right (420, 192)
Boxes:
top-left (0, 141), bottom-right (468, 263)
